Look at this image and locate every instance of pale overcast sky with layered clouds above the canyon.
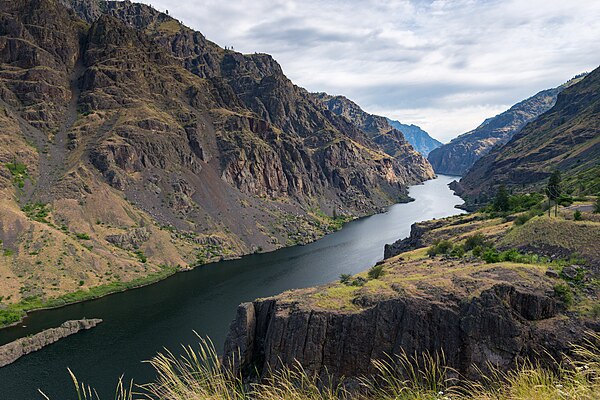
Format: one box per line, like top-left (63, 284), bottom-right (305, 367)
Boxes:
top-left (144, 0), bottom-right (600, 141)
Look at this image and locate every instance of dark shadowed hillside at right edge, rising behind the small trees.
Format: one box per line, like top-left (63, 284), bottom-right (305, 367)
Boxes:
top-left (456, 68), bottom-right (600, 204)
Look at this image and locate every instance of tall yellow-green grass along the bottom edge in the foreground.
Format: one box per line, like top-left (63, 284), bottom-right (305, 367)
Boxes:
top-left (48, 333), bottom-right (600, 400)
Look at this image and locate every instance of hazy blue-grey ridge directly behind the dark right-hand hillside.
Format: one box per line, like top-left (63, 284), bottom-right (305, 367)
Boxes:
top-left (428, 77), bottom-right (581, 175)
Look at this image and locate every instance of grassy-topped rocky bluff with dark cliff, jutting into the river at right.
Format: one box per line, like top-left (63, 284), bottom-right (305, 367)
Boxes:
top-left (224, 214), bottom-right (600, 379)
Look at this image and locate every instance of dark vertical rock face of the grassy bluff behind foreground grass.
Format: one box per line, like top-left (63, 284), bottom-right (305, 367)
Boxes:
top-left (225, 268), bottom-right (583, 379)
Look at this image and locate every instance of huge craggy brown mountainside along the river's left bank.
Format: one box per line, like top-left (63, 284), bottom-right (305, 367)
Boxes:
top-left (0, 0), bottom-right (432, 322)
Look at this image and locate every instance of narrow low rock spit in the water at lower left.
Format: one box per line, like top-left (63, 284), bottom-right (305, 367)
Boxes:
top-left (0, 319), bottom-right (102, 367)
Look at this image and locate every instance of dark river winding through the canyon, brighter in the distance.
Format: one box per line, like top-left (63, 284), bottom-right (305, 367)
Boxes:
top-left (0, 176), bottom-right (462, 400)
